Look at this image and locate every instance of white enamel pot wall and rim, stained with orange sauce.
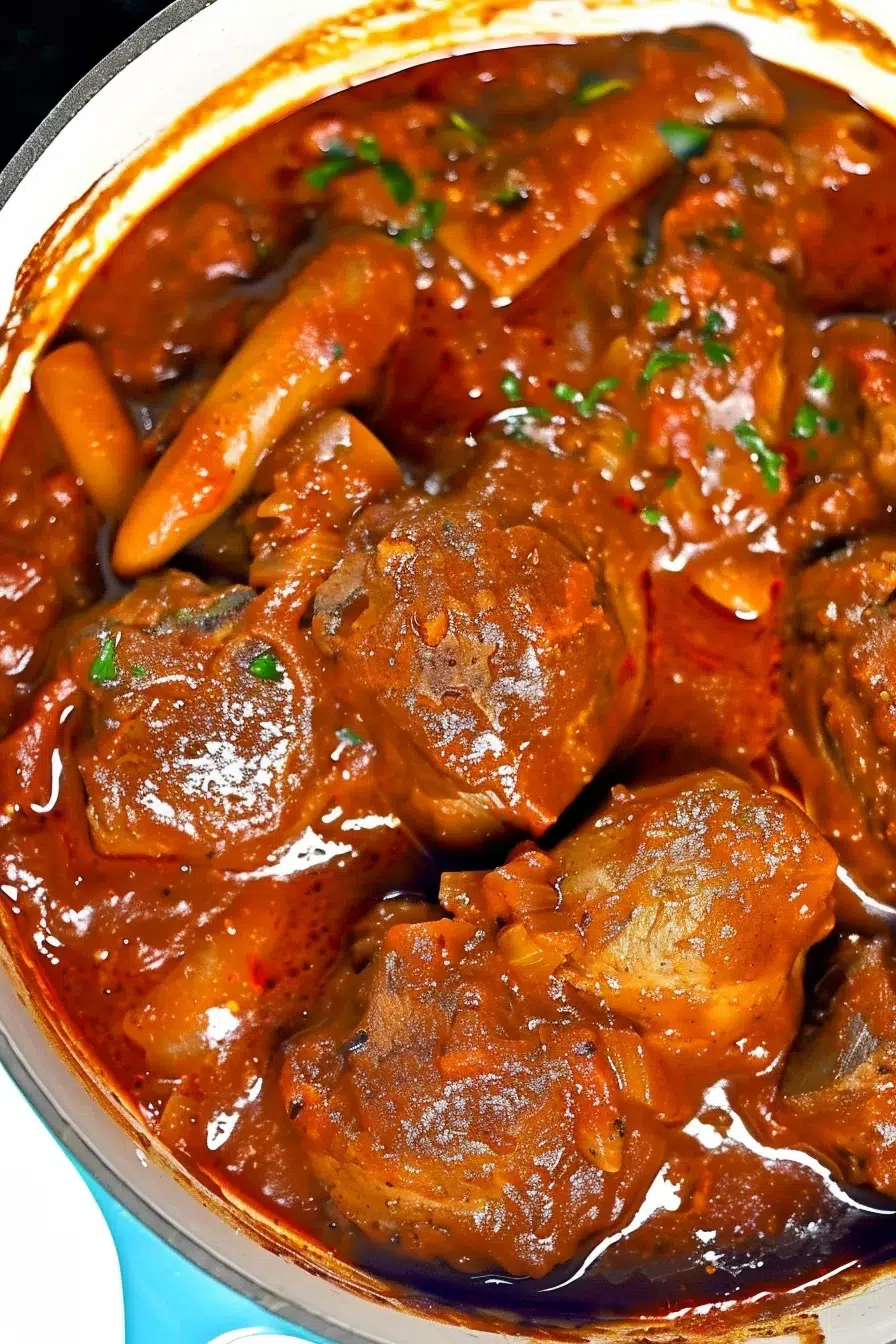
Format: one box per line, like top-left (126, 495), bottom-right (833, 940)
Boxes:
top-left (0, 0), bottom-right (896, 1344)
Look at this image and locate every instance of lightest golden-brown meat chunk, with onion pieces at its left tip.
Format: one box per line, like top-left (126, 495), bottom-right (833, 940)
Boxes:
top-left (456, 770), bottom-right (837, 1078)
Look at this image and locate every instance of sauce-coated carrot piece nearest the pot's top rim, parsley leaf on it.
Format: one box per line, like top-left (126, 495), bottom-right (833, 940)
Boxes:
top-left (438, 31), bottom-right (785, 298)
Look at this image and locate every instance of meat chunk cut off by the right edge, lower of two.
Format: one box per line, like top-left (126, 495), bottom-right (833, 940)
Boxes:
top-left (776, 934), bottom-right (896, 1196)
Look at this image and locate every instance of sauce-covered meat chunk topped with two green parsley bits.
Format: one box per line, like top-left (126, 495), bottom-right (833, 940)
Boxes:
top-left (71, 573), bottom-right (326, 867)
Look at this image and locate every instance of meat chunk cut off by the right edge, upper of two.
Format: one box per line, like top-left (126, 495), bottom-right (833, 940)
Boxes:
top-left (782, 536), bottom-right (896, 902)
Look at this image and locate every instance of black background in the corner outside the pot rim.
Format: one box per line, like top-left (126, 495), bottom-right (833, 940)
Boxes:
top-left (0, 0), bottom-right (168, 168)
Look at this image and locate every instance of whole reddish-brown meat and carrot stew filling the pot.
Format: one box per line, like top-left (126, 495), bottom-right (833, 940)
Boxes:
top-left (0, 28), bottom-right (896, 1321)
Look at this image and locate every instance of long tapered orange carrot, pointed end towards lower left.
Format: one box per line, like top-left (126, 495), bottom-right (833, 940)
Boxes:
top-left (113, 233), bottom-right (414, 575)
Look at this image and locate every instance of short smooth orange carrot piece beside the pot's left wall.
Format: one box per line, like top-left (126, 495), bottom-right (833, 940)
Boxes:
top-left (34, 341), bottom-right (142, 517)
